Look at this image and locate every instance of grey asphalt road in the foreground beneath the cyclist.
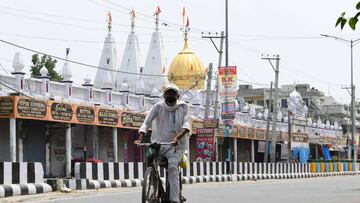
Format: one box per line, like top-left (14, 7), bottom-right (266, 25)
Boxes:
top-left (4, 176), bottom-right (360, 203)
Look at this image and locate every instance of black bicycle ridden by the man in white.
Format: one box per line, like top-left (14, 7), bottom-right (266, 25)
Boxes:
top-left (139, 143), bottom-right (186, 203)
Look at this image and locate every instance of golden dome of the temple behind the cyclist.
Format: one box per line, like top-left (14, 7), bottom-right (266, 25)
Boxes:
top-left (167, 37), bottom-right (206, 90)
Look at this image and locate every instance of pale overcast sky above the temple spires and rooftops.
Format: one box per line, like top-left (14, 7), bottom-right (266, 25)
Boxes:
top-left (0, 0), bottom-right (360, 103)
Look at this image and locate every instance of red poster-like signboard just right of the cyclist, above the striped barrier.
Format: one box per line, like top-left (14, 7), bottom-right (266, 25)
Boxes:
top-left (195, 128), bottom-right (215, 162)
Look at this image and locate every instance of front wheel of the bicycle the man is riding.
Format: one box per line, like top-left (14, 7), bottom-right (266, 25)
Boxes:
top-left (142, 167), bottom-right (160, 203)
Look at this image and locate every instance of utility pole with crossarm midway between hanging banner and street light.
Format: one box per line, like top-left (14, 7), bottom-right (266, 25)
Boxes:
top-left (261, 55), bottom-right (280, 163)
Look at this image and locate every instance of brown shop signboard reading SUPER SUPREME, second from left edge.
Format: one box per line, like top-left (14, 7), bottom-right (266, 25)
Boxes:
top-left (16, 98), bottom-right (47, 119)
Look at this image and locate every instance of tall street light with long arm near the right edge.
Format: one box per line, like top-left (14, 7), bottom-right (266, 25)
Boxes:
top-left (320, 34), bottom-right (360, 163)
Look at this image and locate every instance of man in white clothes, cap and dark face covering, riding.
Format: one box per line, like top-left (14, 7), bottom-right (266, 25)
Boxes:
top-left (134, 84), bottom-right (190, 202)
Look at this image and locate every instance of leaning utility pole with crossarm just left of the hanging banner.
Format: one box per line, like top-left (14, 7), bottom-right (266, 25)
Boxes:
top-left (202, 31), bottom-right (225, 162)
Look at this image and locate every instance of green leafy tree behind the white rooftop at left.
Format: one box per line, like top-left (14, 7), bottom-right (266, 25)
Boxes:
top-left (30, 54), bottom-right (63, 81)
